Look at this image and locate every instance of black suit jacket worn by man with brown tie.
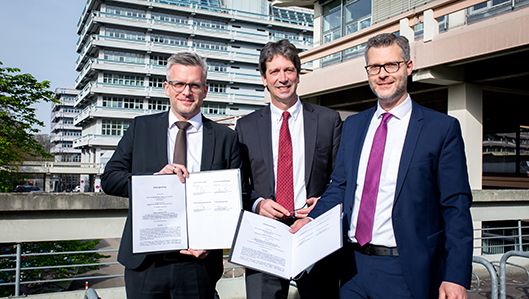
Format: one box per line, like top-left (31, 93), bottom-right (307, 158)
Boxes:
top-left (101, 111), bottom-right (242, 278)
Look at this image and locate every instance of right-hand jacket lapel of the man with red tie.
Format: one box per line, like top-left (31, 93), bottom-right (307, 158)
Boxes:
top-left (301, 102), bottom-right (318, 186)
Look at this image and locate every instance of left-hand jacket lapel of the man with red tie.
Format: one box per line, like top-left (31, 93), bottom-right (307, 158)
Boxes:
top-left (256, 105), bottom-right (275, 190)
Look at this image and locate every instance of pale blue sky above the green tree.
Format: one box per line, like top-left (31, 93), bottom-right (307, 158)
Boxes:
top-left (0, 0), bottom-right (86, 134)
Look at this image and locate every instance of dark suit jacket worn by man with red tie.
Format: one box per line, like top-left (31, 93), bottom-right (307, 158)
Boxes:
top-left (235, 102), bottom-right (342, 211)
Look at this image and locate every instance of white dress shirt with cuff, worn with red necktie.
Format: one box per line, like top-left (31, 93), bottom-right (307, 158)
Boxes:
top-left (253, 98), bottom-right (307, 212)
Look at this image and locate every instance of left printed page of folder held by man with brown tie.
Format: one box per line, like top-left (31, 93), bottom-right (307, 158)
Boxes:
top-left (131, 175), bottom-right (188, 253)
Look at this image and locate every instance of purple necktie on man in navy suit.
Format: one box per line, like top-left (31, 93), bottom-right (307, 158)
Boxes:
top-left (355, 113), bottom-right (393, 246)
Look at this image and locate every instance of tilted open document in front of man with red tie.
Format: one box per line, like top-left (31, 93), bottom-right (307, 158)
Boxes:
top-left (229, 205), bottom-right (343, 279)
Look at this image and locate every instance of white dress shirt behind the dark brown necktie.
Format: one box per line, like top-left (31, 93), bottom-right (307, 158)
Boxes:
top-left (167, 111), bottom-right (202, 173)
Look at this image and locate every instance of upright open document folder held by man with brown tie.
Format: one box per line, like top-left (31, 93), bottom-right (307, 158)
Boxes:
top-left (131, 169), bottom-right (242, 253)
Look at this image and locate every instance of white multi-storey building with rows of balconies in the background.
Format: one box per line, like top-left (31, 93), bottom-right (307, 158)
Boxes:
top-left (74, 0), bottom-right (312, 176)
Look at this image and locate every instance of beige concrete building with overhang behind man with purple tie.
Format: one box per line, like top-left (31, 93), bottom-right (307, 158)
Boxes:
top-left (272, 0), bottom-right (529, 190)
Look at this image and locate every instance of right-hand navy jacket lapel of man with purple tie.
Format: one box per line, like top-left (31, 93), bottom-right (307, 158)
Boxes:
top-left (393, 101), bottom-right (424, 205)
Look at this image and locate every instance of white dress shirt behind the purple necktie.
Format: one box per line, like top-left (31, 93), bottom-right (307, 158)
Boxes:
top-left (348, 95), bottom-right (412, 247)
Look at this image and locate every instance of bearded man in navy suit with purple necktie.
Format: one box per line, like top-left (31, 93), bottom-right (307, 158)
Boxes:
top-left (291, 34), bottom-right (472, 299)
